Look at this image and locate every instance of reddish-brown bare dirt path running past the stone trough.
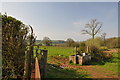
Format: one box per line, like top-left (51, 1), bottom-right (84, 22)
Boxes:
top-left (49, 57), bottom-right (118, 78)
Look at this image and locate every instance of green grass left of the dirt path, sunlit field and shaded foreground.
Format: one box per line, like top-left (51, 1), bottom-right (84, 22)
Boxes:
top-left (35, 46), bottom-right (90, 78)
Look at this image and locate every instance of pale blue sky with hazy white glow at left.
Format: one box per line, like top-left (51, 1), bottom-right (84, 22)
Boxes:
top-left (2, 2), bottom-right (118, 41)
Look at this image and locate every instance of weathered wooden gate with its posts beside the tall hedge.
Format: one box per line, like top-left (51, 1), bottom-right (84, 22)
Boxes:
top-left (25, 45), bottom-right (48, 80)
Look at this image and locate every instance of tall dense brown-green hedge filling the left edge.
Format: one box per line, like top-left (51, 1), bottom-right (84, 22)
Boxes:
top-left (1, 14), bottom-right (34, 78)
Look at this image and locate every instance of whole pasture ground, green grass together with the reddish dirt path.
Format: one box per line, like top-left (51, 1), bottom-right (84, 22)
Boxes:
top-left (36, 46), bottom-right (120, 78)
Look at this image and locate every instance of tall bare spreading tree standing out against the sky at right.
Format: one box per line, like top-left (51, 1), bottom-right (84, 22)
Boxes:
top-left (82, 19), bottom-right (102, 39)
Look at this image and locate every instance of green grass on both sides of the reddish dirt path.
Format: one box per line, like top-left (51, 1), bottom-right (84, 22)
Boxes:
top-left (34, 46), bottom-right (120, 78)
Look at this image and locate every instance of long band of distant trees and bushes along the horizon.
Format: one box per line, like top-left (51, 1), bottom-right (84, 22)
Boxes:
top-left (36, 37), bottom-right (120, 48)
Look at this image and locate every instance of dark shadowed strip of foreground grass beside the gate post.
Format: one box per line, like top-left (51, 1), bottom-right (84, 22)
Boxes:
top-left (46, 64), bottom-right (89, 78)
